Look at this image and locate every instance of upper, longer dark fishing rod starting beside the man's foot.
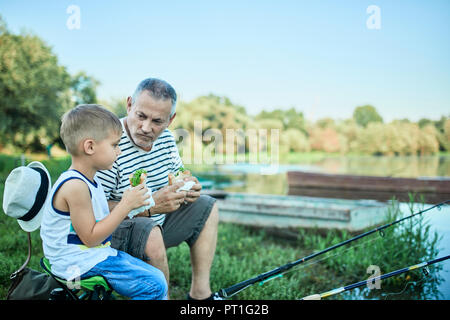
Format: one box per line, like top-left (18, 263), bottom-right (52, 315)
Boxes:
top-left (216, 200), bottom-right (450, 299)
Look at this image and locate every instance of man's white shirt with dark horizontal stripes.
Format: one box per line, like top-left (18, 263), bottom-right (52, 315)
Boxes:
top-left (97, 118), bottom-right (183, 224)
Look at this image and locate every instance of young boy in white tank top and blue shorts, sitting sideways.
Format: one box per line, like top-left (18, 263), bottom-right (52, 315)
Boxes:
top-left (41, 105), bottom-right (168, 300)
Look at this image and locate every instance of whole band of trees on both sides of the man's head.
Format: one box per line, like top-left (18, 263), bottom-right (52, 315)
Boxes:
top-left (0, 17), bottom-right (450, 155)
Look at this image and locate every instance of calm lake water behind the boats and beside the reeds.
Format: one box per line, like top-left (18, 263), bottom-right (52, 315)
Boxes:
top-left (200, 156), bottom-right (450, 300)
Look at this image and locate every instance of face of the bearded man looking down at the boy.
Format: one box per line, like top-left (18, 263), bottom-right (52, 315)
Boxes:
top-left (126, 91), bottom-right (175, 151)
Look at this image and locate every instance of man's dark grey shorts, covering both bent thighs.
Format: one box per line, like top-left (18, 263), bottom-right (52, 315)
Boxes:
top-left (111, 195), bottom-right (216, 261)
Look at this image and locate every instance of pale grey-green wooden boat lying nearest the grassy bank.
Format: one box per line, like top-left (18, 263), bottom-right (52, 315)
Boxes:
top-left (202, 191), bottom-right (388, 231)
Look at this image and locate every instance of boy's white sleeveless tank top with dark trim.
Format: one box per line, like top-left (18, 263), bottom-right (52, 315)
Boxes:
top-left (41, 170), bottom-right (117, 280)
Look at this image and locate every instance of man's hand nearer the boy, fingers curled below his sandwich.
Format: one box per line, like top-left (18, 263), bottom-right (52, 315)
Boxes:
top-left (150, 181), bottom-right (187, 215)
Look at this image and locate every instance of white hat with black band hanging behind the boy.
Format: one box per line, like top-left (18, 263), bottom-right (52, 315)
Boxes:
top-left (3, 161), bottom-right (52, 232)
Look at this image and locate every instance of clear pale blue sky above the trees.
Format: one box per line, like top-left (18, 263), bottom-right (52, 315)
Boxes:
top-left (0, 0), bottom-right (450, 121)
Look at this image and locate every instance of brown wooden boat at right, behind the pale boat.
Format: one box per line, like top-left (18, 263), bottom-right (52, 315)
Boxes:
top-left (287, 171), bottom-right (450, 204)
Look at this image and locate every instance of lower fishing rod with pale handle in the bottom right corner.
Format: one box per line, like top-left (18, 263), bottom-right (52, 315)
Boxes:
top-left (301, 255), bottom-right (450, 300)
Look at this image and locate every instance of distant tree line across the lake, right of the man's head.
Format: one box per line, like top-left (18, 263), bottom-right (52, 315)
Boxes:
top-left (172, 94), bottom-right (450, 155)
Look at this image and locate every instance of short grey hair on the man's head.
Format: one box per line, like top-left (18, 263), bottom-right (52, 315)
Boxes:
top-left (131, 78), bottom-right (177, 117)
